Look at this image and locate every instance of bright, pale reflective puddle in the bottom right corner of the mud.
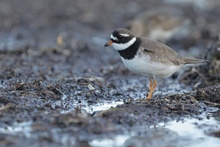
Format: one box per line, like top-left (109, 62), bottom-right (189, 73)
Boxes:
top-left (164, 117), bottom-right (220, 147)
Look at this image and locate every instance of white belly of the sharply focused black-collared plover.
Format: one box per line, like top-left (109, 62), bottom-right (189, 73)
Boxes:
top-left (121, 57), bottom-right (181, 78)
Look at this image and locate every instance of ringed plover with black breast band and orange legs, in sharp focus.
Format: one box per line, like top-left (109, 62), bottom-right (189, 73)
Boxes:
top-left (104, 28), bottom-right (207, 100)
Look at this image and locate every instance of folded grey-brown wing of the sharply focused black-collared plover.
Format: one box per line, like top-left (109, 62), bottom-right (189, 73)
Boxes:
top-left (140, 37), bottom-right (185, 65)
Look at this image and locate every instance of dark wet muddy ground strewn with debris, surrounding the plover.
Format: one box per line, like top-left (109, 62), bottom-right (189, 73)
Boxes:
top-left (0, 0), bottom-right (220, 146)
